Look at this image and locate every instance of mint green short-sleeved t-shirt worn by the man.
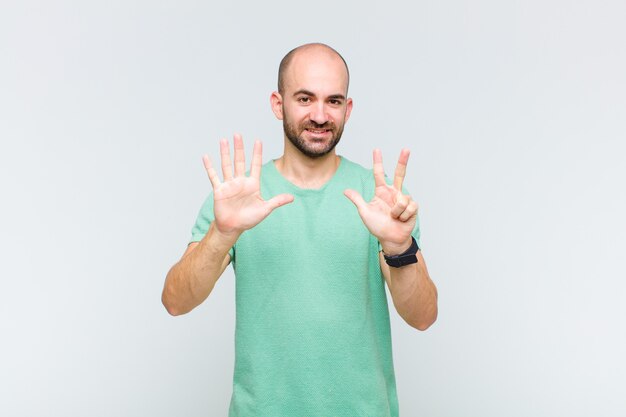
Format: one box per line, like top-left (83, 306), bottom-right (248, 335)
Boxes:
top-left (191, 158), bottom-right (419, 417)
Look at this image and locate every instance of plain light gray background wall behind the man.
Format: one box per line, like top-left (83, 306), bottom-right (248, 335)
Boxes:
top-left (0, 0), bottom-right (626, 417)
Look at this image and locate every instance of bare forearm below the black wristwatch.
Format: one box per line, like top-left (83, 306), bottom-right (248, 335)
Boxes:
top-left (383, 251), bottom-right (437, 330)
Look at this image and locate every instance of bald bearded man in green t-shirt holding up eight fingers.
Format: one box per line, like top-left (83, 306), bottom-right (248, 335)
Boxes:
top-left (162, 44), bottom-right (437, 417)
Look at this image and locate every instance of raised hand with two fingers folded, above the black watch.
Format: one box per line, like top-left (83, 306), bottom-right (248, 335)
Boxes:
top-left (344, 149), bottom-right (418, 255)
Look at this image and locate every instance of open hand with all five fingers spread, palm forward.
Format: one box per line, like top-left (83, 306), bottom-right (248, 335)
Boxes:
top-left (202, 134), bottom-right (293, 234)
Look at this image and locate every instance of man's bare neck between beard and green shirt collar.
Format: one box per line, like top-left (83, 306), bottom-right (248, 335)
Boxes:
top-left (275, 139), bottom-right (341, 189)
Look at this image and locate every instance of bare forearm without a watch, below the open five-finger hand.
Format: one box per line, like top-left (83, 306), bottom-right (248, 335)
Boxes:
top-left (162, 224), bottom-right (237, 315)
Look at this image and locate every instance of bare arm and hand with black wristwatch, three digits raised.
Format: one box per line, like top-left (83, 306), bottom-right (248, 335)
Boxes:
top-left (345, 150), bottom-right (437, 330)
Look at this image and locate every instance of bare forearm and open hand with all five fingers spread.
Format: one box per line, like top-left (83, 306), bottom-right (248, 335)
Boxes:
top-left (161, 135), bottom-right (293, 315)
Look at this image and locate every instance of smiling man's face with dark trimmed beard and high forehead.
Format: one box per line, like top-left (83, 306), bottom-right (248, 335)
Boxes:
top-left (282, 48), bottom-right (352, 158)
